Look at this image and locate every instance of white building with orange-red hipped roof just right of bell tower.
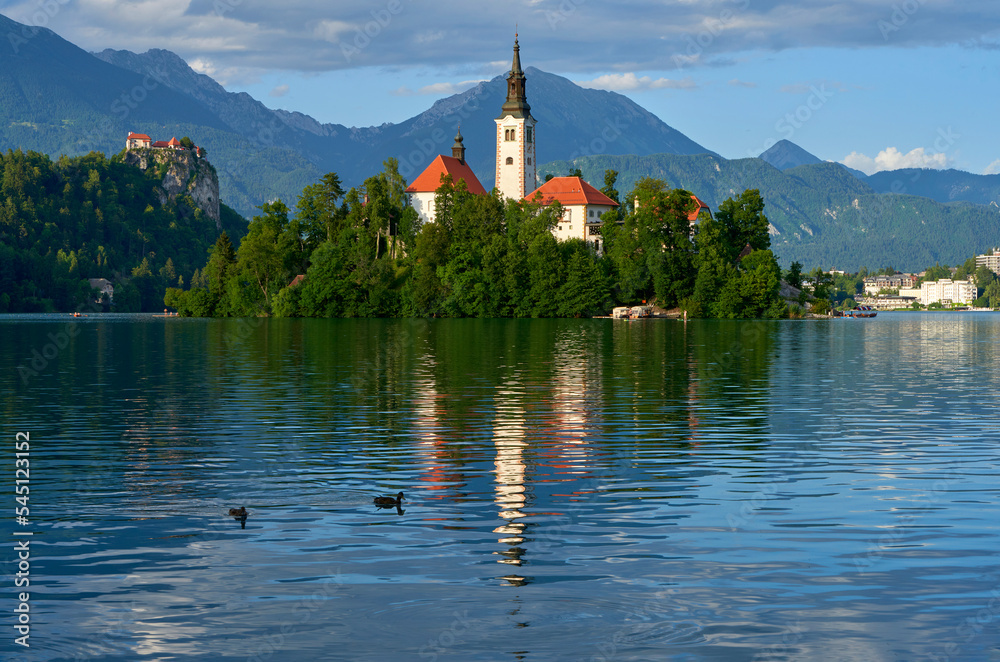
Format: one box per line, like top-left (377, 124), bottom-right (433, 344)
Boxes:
top-left (524, 177), bottom-right (619, 252)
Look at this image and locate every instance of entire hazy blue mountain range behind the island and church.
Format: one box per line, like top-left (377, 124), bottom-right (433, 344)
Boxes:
top-left (0, 15), bottom-right (1000, 270)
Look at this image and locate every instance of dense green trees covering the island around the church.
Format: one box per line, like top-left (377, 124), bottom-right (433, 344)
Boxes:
top-left (164, 159), bottom-right (786, 318)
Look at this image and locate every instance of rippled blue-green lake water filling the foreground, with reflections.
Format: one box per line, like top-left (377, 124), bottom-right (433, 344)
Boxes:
top-left (0, 313), bottom-right (1000, 662)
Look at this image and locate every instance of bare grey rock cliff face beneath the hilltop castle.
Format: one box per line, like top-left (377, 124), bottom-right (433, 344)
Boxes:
top-left (125, 148), bottom-right (222, 232)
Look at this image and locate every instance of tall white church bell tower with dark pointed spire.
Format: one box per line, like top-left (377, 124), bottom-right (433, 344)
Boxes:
top-left (494, 35), bottom-right (537, 200)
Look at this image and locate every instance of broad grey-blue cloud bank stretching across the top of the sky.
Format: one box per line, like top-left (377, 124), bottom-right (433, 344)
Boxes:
top-left (21, 0), bottom-right (1000, 76)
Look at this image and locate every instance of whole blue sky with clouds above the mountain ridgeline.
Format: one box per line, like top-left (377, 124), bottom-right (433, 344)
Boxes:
top-left (0, 0), bottom-right (1000, 174)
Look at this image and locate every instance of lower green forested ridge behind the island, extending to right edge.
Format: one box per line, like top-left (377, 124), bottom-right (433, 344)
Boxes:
top-left (539, 154), bottom-right (1000, 271)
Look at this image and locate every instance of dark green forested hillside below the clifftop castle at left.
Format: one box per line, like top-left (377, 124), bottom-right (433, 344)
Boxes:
top-left (0, 151), bottom-right (245, 312)
